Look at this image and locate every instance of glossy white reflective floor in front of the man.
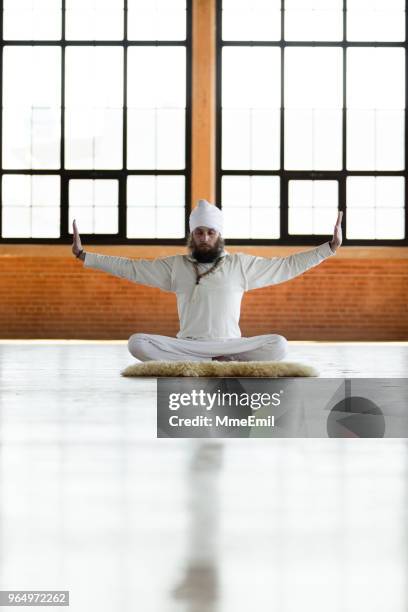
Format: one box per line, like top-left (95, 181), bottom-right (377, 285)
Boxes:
top-left (0, 340), bottom-right (408, 612)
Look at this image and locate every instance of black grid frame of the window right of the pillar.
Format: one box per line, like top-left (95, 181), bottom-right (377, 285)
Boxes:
top-left (216, 0), bottom-right (408, 246)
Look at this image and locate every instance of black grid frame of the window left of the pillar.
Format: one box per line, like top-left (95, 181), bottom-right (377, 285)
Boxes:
top-left (0, 0), bottom-right (192, 245)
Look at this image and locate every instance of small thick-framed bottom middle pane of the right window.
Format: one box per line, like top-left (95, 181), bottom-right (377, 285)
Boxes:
top-left (288, 180), bottom-right (339, 234)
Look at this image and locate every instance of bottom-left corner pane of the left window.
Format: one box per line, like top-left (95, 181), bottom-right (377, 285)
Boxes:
top-left (2, 174), bottom-right (60, 238)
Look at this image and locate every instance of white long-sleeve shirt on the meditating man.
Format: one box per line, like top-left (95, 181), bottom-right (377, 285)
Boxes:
top-left (84, 242), bottom-right (335, 340)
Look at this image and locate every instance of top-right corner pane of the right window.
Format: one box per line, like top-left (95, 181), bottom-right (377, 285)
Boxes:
top-left (347, 0), bottom-right (405, 42)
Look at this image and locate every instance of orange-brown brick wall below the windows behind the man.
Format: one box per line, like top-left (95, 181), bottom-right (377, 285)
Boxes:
top-left (0, 245), bottom-right (408, 340)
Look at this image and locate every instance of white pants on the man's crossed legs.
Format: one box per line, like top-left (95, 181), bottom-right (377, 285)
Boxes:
top-left (128, 334), bottom-right (288, 361)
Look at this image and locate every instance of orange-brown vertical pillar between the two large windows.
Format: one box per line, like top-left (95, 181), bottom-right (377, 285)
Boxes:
top-left (191, 0), bottom-right (216, 208)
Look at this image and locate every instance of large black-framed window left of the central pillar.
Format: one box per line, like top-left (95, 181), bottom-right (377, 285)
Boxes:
top-left (0, 0), bottom-right (191, 244)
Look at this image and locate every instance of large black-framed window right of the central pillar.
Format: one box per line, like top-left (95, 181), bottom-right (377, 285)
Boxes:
top-left (217, 0), bottom-right (408, 245)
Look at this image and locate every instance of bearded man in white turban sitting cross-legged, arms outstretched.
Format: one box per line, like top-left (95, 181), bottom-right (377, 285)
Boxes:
top-left (72, 200), bottom-right (343, 361)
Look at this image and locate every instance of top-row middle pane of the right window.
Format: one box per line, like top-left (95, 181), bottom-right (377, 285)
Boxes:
top-left (285, 0), bottom-right (343, 40)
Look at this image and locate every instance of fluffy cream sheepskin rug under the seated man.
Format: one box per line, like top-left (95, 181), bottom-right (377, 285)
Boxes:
top-left (121, 361), bottom-right (319, 378)
